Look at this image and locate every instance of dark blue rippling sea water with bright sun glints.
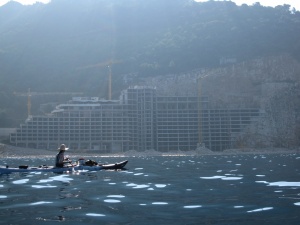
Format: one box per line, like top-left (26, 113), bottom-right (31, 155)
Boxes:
top-left (0, 154), bottom-right (300, 225)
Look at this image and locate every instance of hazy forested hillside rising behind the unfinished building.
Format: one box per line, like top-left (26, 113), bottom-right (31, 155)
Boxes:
top-left (0, 0), bottom-right (300, 127)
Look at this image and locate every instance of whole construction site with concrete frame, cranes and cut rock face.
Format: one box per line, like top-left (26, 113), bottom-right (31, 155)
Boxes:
top-left (10, 56), bottom-right (299, 153)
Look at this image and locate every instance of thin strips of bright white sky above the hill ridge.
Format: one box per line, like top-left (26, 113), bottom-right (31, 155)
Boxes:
top-left (0, 0), bottom-right (300, 11)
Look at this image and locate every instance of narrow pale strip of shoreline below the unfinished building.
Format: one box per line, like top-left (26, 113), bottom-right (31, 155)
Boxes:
top-left (0, 144), bottom-right (300, 158)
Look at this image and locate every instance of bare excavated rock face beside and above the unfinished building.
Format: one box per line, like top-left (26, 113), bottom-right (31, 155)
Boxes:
top-left (145, 55), bottom-right (300, 147)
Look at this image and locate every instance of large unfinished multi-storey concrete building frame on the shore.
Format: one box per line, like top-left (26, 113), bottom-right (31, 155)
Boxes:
top-left (10, 86), bottom-right (261, 153)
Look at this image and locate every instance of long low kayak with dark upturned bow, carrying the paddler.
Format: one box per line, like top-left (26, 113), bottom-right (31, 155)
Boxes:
top-left (0, 160), bottom-right (128, 174)
